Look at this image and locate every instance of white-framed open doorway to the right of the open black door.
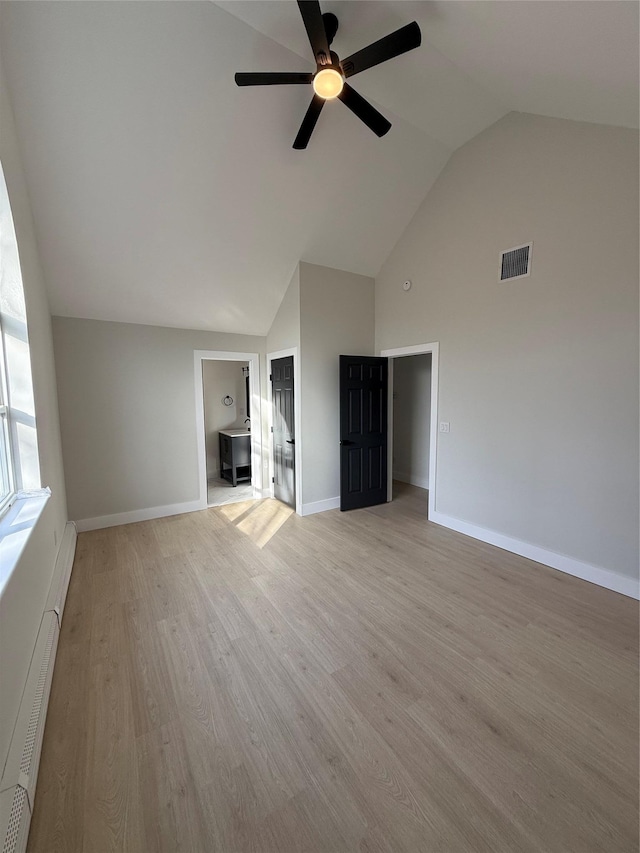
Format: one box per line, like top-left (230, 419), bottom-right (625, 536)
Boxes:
top-left (381, 343), bottom-right (438, 518)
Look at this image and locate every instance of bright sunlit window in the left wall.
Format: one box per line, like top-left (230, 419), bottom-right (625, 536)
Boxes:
top-left (0, 165), bottom-right (40, 515)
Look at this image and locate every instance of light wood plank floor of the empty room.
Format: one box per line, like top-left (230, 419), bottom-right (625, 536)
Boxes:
top-left (29, 485), bottom-right (638, 853)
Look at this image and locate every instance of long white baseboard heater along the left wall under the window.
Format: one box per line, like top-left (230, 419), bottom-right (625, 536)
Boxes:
top-left (0, 522), bottom-right (76, 853)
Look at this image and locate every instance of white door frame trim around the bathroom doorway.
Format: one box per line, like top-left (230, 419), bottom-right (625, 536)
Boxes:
top-left (193, 350), bottom-right (262, 509)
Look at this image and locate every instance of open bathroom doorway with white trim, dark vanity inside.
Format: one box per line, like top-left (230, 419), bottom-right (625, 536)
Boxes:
top-left (195, 351), bottom-right (262, 509)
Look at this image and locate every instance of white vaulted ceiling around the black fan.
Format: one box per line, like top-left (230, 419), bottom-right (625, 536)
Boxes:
top-left (0, 0), bottom-right (638, 334)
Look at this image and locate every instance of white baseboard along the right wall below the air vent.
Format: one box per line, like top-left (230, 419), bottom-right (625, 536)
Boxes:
top-left (429, 512), bottom-right (640, 599)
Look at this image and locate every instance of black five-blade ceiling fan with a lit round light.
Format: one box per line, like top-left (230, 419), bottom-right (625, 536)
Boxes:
top-left (235, 0), bottom-right (422, 149)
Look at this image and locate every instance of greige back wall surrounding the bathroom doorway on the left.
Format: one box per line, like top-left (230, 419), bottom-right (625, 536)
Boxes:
top-left (53, 317), bottom-right (266, 520)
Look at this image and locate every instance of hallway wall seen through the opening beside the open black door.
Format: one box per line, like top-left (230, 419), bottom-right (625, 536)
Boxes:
top-left (392, 354), bottom-right (431, 489)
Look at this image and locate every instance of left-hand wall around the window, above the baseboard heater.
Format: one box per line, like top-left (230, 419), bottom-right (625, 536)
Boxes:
top-left (0, 55), bottom-right (67, 769)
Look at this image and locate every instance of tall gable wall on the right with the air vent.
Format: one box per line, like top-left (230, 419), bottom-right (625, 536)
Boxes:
top-left (376, 113), bottom-right (639, 577)
